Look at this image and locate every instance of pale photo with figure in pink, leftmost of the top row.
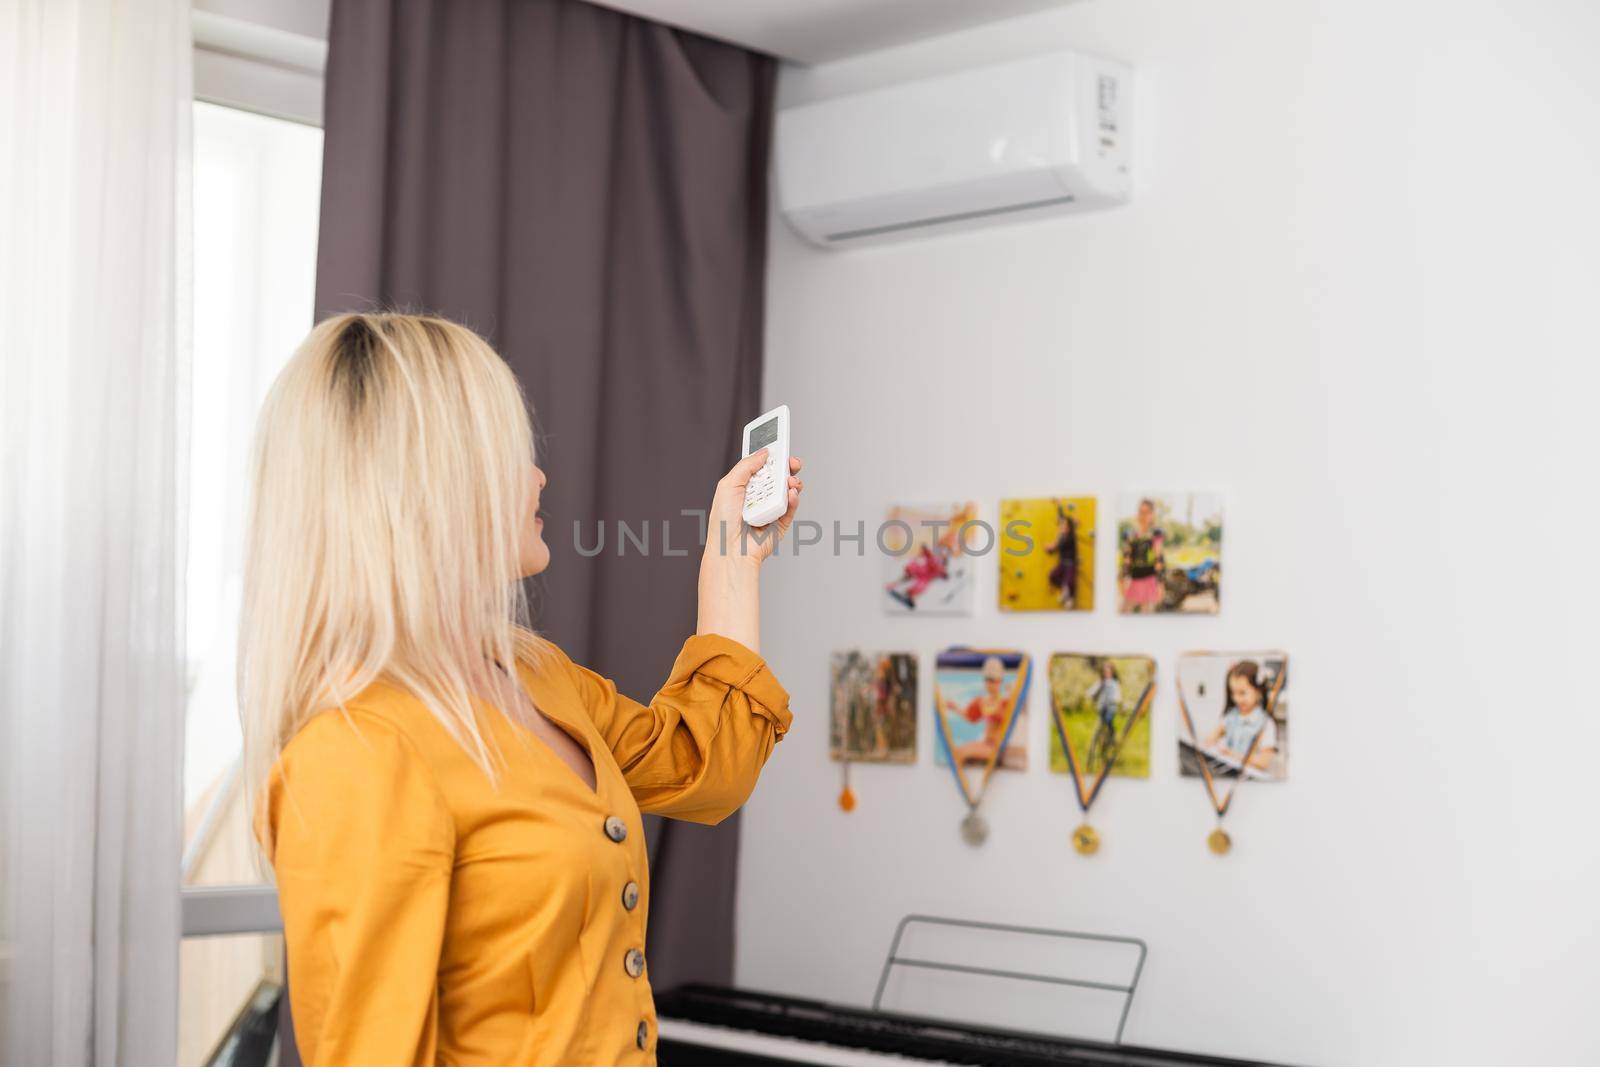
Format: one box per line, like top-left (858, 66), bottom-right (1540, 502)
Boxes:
top-left (878, 502), bottom-right (986, 614)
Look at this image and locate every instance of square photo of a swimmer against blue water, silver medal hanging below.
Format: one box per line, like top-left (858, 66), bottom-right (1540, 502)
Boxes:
top-left (933, 648), bottom-right (1032, 771)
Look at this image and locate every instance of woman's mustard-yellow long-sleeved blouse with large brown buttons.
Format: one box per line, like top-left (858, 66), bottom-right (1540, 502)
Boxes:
top-left (264, 635), bottom-right (790, 1067)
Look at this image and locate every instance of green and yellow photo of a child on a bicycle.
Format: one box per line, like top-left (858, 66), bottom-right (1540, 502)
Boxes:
top-left (1050, 653), bottom-right (1155, 777)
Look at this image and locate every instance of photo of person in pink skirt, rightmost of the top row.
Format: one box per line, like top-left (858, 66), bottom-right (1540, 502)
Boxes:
top-left (1117, 493), bottom-right (1222, 614)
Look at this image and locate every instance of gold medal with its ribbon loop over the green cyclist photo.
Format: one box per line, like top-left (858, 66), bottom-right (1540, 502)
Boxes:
top-left (1050, 653), bottom-right (1155, 856)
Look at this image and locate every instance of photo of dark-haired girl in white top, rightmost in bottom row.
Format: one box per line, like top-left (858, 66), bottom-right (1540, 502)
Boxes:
top-left (1178, 653), bottom-right (1290, 782)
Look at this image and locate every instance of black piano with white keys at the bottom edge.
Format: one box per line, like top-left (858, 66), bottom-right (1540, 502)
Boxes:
top-left (656, 985), bottom-right (1292, 1067)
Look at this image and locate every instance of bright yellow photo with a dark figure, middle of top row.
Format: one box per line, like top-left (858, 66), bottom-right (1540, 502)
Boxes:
top-left (1000, 496), bottom-right (1094, 611)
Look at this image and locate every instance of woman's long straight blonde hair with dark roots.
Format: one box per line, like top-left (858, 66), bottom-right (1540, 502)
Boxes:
top-left (238, 314), bottom-right (544, 848)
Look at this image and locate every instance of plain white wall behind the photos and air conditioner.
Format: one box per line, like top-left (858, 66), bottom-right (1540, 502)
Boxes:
top-left (738, 0), bottom-right (1600, 1065)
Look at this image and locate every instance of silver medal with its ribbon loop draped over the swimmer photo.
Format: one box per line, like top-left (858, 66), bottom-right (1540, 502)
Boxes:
top-left (933, 648), bottom-right (1032, 846)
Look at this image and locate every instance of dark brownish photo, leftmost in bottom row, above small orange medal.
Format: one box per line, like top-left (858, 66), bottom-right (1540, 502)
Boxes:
top-left (829, 651), bottom-right (917, 763)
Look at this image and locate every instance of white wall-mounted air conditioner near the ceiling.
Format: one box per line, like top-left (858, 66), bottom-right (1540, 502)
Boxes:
top-left (774, 53), bottom-right (1133, 248)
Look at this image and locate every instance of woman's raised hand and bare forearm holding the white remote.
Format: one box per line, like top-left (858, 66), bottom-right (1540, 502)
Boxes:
top-left (696, 448), bottom-right (805, 653)
